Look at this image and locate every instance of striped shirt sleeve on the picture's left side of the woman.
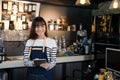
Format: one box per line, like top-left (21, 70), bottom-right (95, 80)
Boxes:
top-left (24, 41), bottom-right (33, 67)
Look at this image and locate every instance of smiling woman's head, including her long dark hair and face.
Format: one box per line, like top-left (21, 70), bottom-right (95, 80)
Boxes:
top-left (29, 17), bottom-right (47, 39)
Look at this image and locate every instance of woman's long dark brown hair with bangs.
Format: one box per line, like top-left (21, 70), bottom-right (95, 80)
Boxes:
top-left (28, 17), bottom-right (48, 40)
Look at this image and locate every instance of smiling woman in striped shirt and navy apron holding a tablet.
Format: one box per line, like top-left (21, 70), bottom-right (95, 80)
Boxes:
top-left (24, 17), bottom-right (57, 80)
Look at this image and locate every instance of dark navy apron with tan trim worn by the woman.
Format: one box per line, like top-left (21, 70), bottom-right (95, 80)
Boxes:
top-left (28, 39), bottom-right (52, 80)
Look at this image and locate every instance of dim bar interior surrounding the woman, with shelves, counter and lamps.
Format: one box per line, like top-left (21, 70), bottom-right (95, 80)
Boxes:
top-left (0, 0), bottom-right (120, 80)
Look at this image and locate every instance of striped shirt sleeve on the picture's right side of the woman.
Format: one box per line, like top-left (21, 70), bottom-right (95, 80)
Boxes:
top-left (48, 40), bottom-right (57, 70)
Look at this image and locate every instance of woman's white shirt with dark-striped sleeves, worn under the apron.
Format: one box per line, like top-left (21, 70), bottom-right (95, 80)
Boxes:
top-left (24, 38), bottom-right (57, 70)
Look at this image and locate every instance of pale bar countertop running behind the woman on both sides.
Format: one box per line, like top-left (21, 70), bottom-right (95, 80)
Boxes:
top-left (0, 55), bottom-right (94, 69)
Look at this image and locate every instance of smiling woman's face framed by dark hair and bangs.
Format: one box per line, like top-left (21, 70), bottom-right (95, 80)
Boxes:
top-left (35, 25), bottom-right (46, 37)
